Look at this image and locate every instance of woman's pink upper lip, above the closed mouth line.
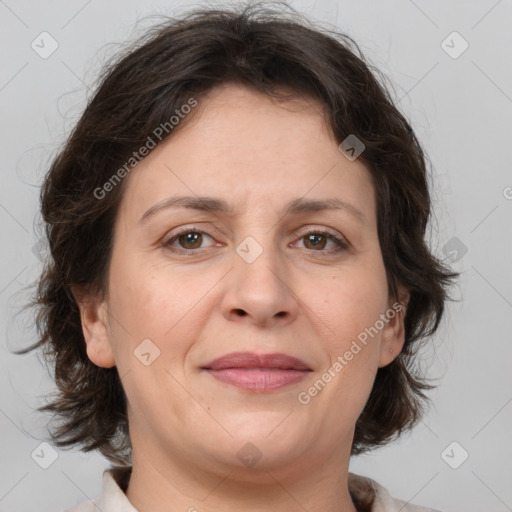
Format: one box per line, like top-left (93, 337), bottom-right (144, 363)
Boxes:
top-left (203, 352), bottom-right (311, 371)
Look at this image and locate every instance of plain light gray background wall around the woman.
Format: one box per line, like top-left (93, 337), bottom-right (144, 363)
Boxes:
top-left (0, 0), bottom-right (512, 512)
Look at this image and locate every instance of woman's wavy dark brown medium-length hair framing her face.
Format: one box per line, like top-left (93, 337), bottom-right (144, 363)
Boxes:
top-left (19, 3), bottom-right (456, 464)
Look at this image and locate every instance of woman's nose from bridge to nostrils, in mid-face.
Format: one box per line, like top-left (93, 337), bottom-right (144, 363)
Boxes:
top-left (222, 240), bottom-right (300, 328)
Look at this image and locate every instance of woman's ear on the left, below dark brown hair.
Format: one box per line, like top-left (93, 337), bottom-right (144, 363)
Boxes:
top-left (73, 287), bottom-right (115, 368)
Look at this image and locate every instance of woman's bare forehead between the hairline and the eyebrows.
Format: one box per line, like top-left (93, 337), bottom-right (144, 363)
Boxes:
top-left (117, 85), bottom-right (375, 224)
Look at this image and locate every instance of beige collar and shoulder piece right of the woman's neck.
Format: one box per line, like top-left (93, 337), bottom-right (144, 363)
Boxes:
top-left (348, 473), bottom-right (441, 512)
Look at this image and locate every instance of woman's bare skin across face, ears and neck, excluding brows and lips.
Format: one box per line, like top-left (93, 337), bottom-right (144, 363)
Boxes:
top-left (80, 85), bottom-right (406, 512)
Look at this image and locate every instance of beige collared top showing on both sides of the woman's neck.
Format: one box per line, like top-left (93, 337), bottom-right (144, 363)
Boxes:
top-left (66, 467), bottom-right (440, 512)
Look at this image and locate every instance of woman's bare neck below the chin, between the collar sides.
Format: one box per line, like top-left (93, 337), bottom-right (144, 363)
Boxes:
top-left (126, 444), bottom-right (357, 512)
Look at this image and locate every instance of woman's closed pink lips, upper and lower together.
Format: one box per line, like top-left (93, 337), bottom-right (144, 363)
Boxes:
top-left (202, 352), bottom-right (313, 392)
